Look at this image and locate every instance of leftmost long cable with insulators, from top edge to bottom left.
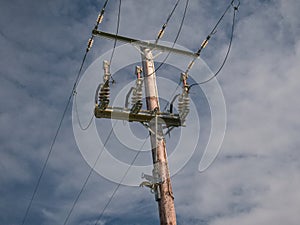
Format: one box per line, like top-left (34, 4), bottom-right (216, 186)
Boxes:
top-left (22, 0), bottom-right (109, 225)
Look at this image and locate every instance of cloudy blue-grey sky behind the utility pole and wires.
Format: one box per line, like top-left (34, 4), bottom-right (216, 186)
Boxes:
top-left (0, 0), bottom-right (300, 225)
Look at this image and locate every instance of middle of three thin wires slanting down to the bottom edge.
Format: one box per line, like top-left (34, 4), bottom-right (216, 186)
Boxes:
top-left (64, 122), bottom-right (117, 225)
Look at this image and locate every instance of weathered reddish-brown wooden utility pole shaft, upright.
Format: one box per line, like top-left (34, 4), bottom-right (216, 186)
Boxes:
top-left (141, 48), bottom-right (176, 225)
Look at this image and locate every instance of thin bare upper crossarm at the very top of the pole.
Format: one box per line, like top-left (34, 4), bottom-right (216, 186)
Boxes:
top-left (92, 29), bottom-right (199, 58)
